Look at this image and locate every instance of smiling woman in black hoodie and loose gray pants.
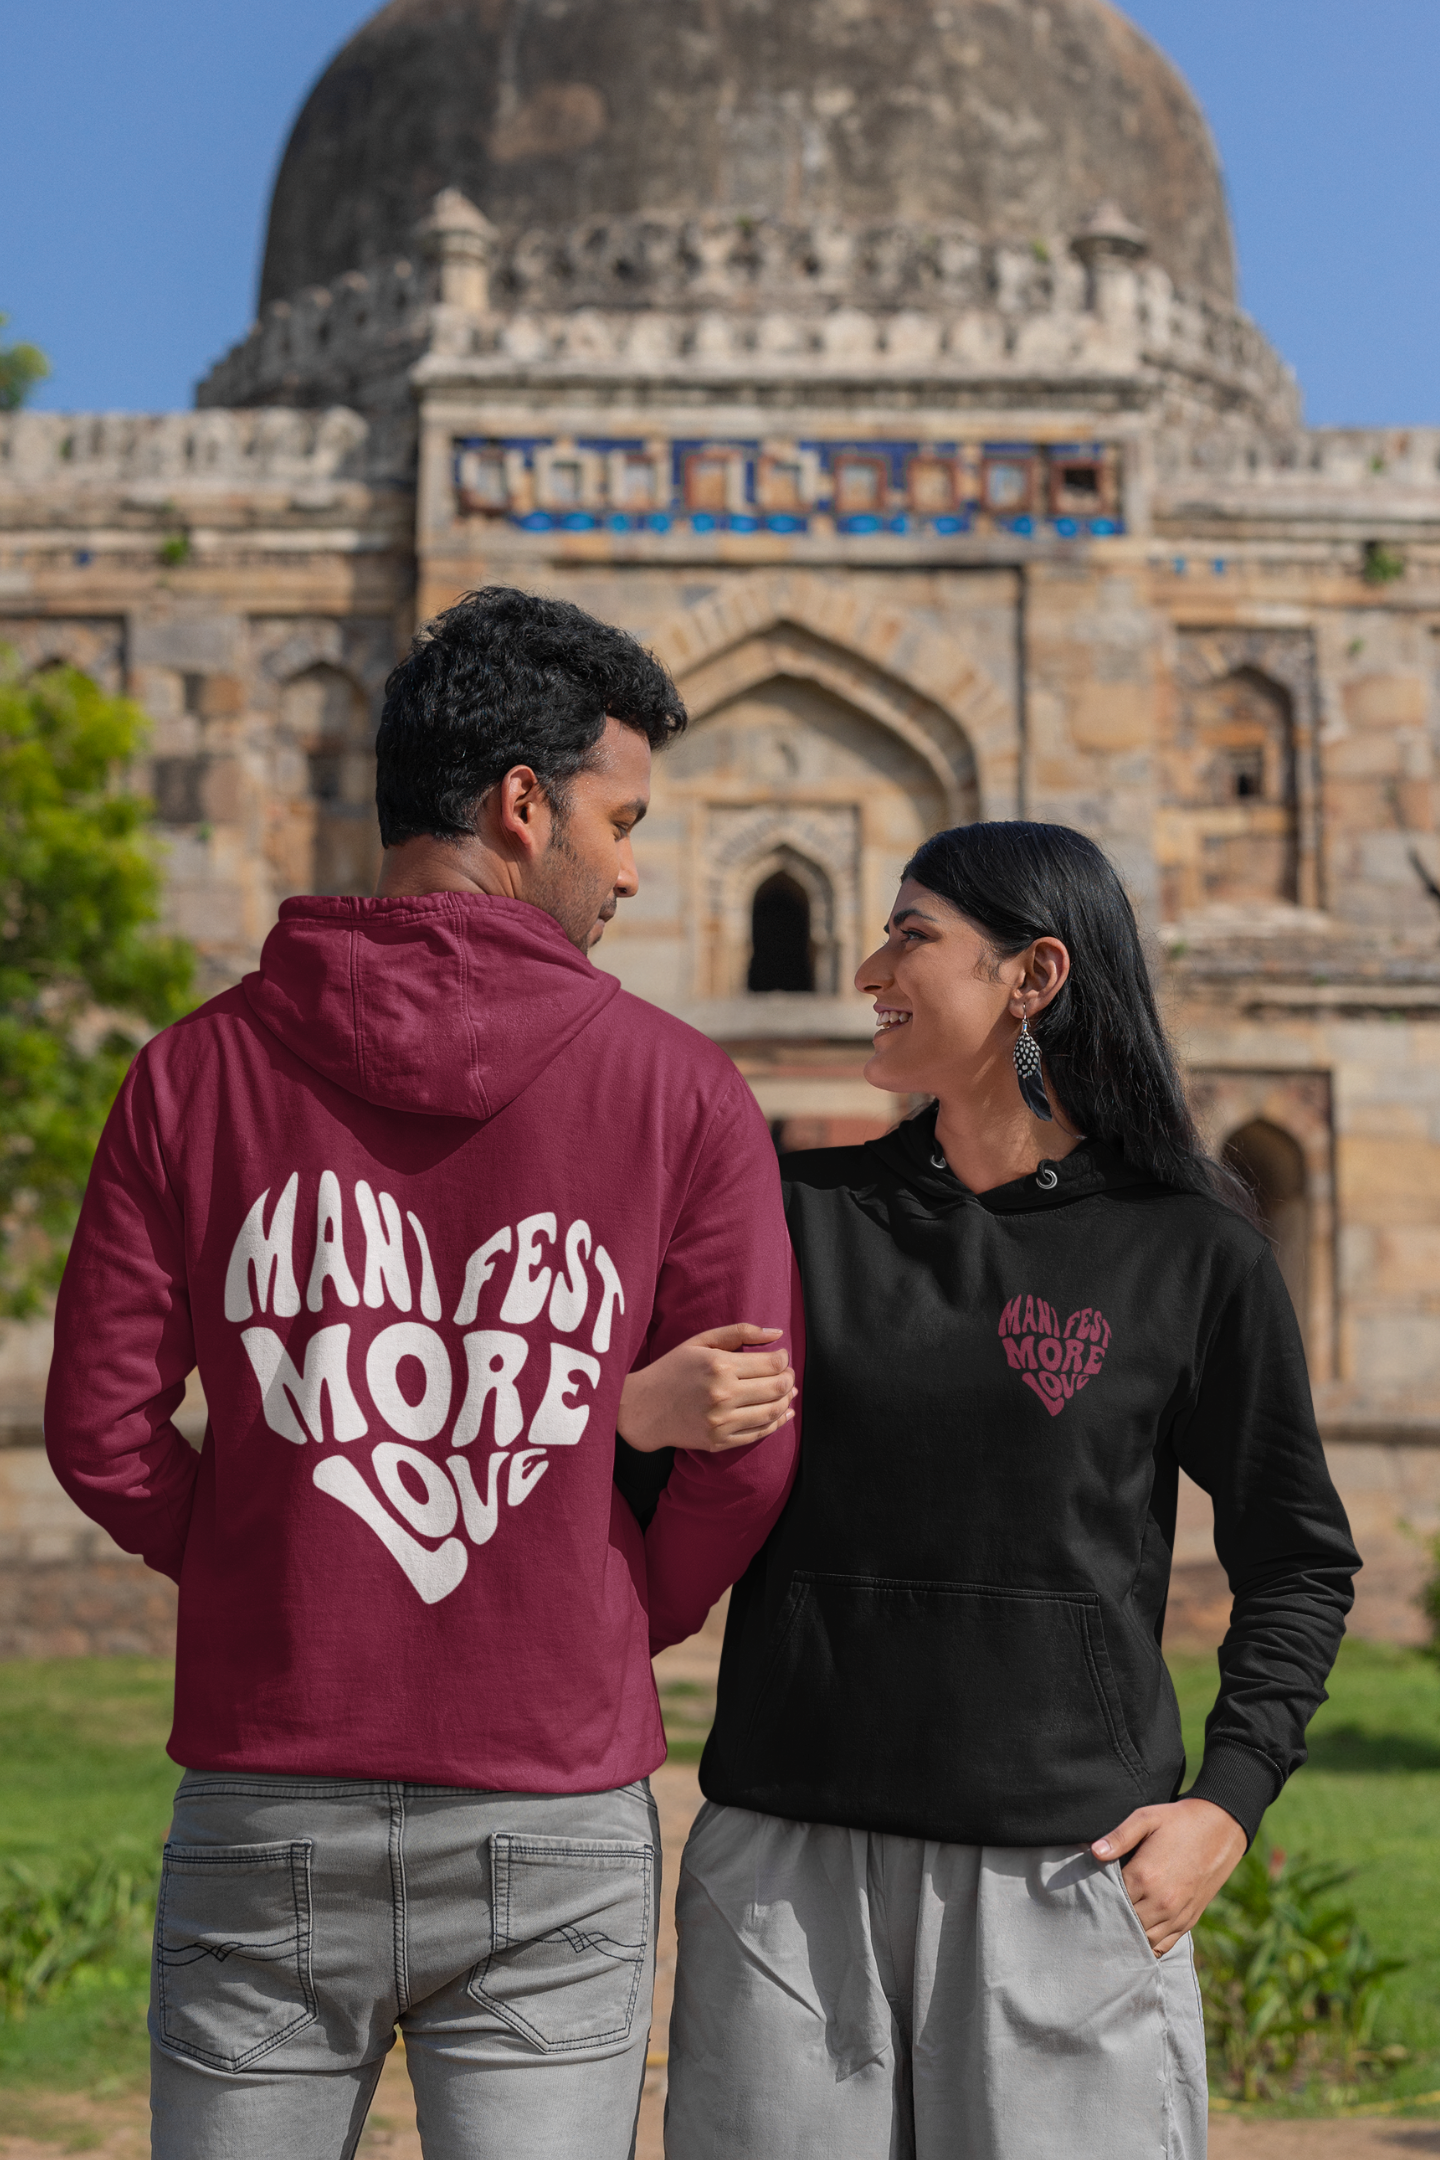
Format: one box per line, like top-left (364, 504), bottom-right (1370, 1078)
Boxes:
top-left (667, 823), bottom-right (1358, 2160)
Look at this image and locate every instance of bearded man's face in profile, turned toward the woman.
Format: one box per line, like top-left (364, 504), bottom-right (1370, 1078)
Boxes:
top-left (525, 719), bottom-right (650, 953)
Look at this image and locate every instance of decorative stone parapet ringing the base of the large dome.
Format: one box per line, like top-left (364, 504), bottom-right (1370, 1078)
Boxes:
top-left (196, 190), bottom-right (1300, 428)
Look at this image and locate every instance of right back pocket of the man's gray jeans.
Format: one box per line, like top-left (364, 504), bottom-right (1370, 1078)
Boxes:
top-left (466, 1830), bottom-right (654, 2054)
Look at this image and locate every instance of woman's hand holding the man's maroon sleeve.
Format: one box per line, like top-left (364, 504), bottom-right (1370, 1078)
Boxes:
top-left (617, 1320), bottom-right (794, 1456)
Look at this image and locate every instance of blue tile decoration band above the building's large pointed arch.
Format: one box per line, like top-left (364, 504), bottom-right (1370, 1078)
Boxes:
top-left (453, 436), bottom-right (1125, 540)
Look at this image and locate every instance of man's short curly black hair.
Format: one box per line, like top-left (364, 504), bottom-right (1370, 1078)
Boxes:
top-left (376, 585), bottom-right (687, 847)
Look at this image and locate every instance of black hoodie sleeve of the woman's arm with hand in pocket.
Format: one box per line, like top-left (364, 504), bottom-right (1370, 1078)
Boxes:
top-left (1174, 1246), bottom-right (1360, 1838)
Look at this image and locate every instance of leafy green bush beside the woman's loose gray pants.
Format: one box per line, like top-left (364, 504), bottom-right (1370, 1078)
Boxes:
top-left (1194, 1840), bottom-right (1405, 2100)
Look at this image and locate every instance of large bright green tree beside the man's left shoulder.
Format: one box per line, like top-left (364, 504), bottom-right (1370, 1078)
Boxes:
top-left (0, 648), bottom-right (194, 1318)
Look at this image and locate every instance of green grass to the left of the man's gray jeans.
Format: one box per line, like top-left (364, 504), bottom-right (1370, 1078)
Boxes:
top-left (0, 1657), bottom-right (179, 2099)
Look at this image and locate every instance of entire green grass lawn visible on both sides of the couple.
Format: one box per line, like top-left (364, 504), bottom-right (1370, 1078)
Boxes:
top-left (0, 1642), bottom-right (1440, 2097)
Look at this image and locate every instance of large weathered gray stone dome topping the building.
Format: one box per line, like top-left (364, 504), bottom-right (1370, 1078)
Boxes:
top-left (261, 0), bottom-right (1235, 305)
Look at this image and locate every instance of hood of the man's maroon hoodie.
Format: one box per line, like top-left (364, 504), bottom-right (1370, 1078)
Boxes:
top-left (242, 892), bottom-right (620, 1119)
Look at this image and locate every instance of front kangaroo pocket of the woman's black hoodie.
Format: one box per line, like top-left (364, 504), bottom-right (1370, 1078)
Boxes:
top-left (747, 1572), bottom-right (1144, 1845)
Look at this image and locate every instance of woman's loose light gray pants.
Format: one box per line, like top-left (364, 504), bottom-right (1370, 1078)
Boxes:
top-left (665, 1804), bottom-right (1207, 2160)
